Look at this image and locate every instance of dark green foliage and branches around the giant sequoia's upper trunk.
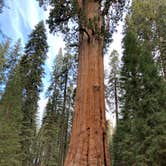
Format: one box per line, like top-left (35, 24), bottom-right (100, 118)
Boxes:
top-left (37, 0), bottom-right (128, 52)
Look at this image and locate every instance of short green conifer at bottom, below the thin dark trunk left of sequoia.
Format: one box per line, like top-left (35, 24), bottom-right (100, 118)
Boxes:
top-left (37, 104), bottom-right (60, 166)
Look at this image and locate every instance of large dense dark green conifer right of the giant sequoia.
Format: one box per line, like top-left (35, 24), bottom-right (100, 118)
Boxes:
top-left (114, 28), bottom-right (166, 166)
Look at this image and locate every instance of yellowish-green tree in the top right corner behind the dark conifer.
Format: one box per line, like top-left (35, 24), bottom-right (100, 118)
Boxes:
top-left (128, 0), bottom-right (166, 78)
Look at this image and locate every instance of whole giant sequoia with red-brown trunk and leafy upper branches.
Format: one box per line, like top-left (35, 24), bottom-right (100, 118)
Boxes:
top-left (37, 0), bottom-right (124, 166)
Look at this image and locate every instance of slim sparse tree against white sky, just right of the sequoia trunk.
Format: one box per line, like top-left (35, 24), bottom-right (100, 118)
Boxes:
top-left (105, 50), bottom-right (120, 164)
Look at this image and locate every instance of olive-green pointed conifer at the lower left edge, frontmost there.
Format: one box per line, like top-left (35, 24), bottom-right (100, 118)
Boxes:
top-left (0, 68), bottom-right (22, 165)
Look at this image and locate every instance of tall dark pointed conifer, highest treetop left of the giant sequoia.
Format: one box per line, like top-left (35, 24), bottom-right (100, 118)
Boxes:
top-left (21, 21), bottom-right (48, 166)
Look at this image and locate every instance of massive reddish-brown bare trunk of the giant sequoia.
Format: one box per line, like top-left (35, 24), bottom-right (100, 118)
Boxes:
top-left (64, 1), bottom-right (110, 166)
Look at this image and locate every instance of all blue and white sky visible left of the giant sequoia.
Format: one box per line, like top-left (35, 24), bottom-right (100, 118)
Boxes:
top-left (0, 0), bottom-right (64, 126)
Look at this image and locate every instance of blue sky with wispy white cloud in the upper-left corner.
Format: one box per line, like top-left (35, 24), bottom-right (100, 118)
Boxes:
top-left (0, 0), bottom-right (42, 43)
